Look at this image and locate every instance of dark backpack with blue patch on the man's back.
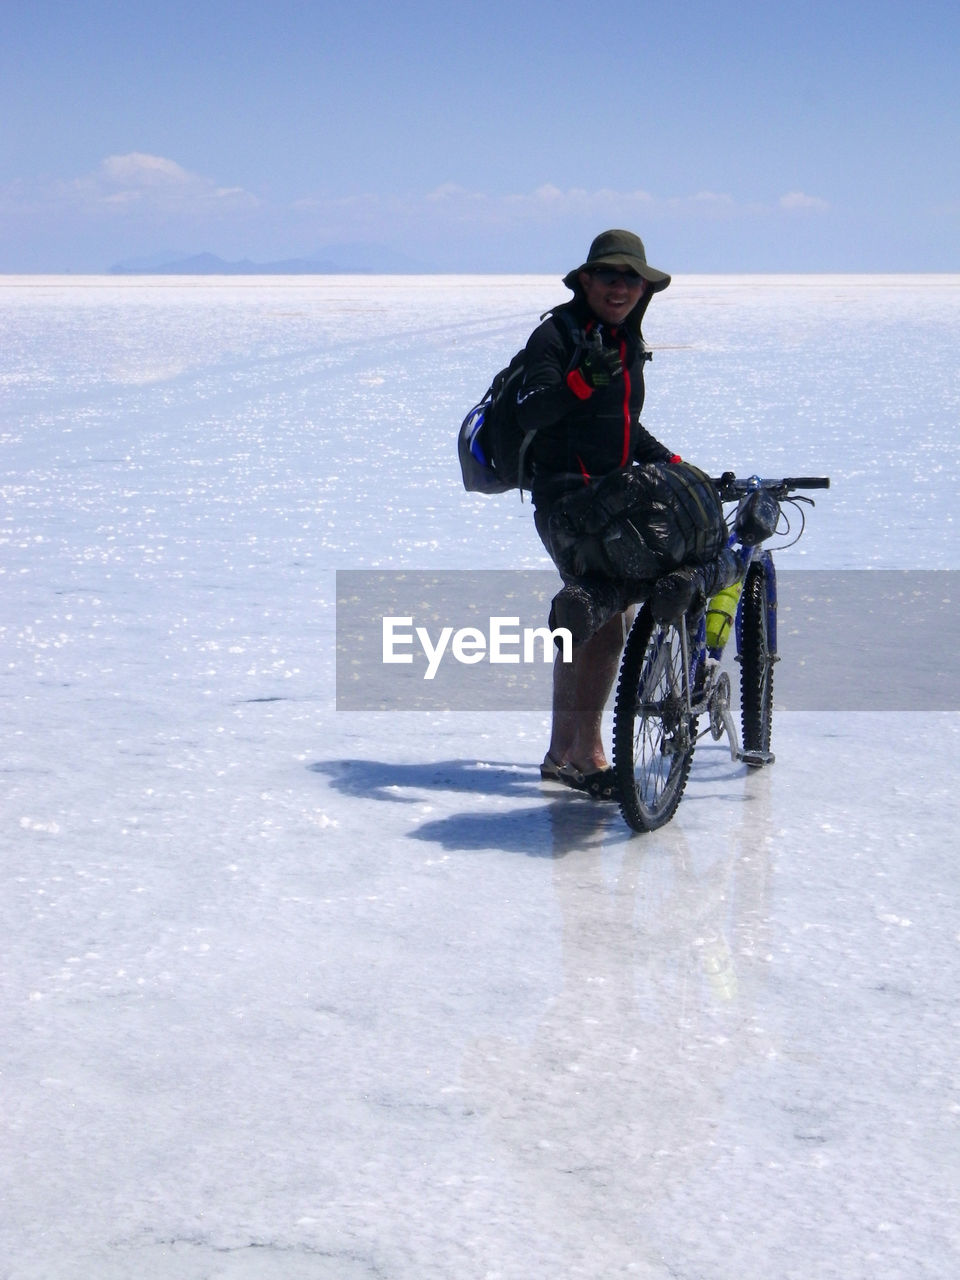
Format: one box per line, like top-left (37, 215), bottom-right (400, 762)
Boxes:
top-left (457, 307), bottom-right (585, 498)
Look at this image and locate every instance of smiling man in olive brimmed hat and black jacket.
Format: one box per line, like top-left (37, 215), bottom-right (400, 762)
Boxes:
top-left (517, 230), bottom-right (680, 800)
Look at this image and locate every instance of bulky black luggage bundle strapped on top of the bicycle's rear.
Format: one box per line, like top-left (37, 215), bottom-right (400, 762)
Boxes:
top-left (549, 462), bottom-right (727, 581)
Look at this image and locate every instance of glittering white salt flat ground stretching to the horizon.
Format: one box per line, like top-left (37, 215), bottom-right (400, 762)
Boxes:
top-left (0, 276), bottom-right (960, 1280)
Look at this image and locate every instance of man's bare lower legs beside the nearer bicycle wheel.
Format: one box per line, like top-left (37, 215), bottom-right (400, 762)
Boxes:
top-left (550, 613), bottom-right (630, 773)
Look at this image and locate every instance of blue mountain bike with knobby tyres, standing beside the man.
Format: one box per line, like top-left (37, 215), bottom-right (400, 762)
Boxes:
top-left (613, 472), bottom-right (829, 832)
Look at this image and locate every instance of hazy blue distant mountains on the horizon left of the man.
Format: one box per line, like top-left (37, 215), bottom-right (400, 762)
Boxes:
top-left (110, 244), bottom-right (430, 275)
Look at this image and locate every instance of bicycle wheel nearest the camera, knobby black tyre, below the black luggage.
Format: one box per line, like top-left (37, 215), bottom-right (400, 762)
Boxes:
top-left (613, 604), bottom-right (696, 831)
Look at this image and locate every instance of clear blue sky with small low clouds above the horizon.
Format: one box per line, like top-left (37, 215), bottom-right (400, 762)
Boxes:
top-left (0, 0), bottom-right (960, 274)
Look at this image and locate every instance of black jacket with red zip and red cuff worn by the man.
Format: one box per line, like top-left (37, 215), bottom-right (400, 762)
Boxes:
top-left (517, 298), bottom-right (672, 506)
